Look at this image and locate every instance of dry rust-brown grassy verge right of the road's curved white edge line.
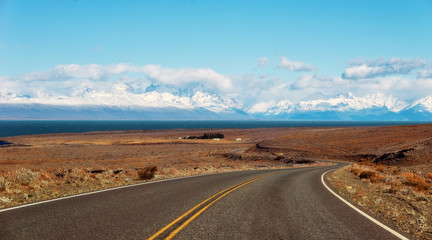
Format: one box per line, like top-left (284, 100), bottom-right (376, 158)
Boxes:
top-left (327, 163), bottom-right (432, 240)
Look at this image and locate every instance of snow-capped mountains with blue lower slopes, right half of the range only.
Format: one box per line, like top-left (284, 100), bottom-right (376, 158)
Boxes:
top-left (248, 93), bottom-right (432, 121)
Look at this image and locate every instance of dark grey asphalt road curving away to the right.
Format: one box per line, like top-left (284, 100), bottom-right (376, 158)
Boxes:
top-left (0, 166), bottom-right (406, 240)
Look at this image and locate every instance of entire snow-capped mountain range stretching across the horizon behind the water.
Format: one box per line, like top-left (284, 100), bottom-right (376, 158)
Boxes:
top-left (0, 88), bottom-right (432, 121)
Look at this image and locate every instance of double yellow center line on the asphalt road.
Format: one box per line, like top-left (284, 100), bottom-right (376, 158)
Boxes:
top-left (147, 174), bottom-right (271, 240)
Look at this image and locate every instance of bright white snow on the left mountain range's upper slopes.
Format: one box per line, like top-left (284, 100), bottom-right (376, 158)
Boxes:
top-left (0, 84), bottom-right (242, 113)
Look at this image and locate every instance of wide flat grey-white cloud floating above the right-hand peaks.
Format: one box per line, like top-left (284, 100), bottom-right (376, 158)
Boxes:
top-left (342, 58), bottom-right (427, 79)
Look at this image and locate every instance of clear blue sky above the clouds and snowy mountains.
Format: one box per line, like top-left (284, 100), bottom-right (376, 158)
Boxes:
top-left (0, 0), bottom-right (432, 108)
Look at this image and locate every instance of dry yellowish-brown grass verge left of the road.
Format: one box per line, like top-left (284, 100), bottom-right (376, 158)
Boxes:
top-left (0, 168), bottom-right (136, 208)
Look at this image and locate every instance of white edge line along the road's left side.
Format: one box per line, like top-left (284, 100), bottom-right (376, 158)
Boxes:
top-left (0, 172), bottom-right (223, 213)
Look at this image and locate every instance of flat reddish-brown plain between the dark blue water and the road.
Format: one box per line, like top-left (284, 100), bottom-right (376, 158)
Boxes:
top-left (0, 125), bottom-right (432, 172)
